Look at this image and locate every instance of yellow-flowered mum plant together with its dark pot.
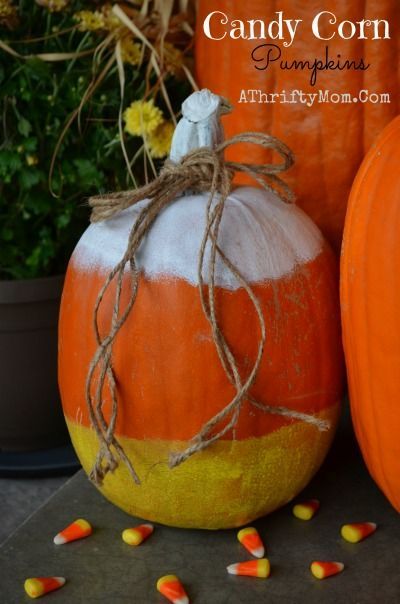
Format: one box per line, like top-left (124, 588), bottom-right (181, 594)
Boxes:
top-left (0, 0), bottom-right (193, 450)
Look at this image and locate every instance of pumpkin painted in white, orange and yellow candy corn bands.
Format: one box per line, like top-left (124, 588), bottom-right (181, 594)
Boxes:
top-left (59, 93), bottom-right (343, 529)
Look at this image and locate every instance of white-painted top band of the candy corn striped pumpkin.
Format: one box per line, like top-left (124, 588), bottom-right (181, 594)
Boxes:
top-left (71, 187), bottom-right (323, 290)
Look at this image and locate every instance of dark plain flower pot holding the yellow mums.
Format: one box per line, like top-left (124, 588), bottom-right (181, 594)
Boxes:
top-left (0, 276), bottom-right (68, 451)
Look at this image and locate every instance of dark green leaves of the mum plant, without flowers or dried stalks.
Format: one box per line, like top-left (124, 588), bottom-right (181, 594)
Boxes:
top-left (0, 0), bottom-right (188, 279)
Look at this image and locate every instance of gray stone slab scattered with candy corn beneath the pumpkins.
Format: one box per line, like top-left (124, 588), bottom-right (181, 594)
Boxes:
top-left (0, 416), bottom-right (400, 604)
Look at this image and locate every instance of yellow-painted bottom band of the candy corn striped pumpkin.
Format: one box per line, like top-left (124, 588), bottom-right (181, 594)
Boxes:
top-left (67, 404), bottom-right (339, 529)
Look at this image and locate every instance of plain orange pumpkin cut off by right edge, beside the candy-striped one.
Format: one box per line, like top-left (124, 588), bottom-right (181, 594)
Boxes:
top-left (341, 117), bottom-right (400, 512)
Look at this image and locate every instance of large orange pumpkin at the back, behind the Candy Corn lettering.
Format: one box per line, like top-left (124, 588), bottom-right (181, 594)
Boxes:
top-left (196, 0), bottom-right (400, 251)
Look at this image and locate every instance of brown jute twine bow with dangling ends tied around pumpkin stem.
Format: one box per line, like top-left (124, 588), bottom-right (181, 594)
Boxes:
top-left (86, 132), bottom-right (329, 485)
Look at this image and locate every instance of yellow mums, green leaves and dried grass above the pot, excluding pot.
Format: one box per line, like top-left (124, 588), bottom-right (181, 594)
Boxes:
top-left (0, 0), bottom-right (195, 279)
